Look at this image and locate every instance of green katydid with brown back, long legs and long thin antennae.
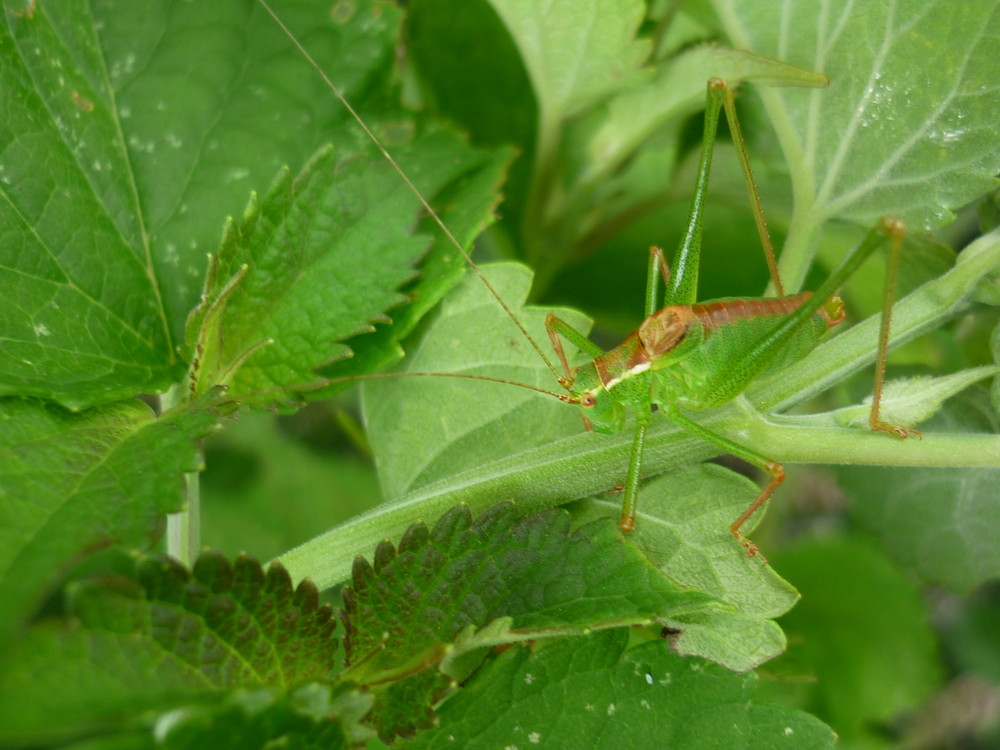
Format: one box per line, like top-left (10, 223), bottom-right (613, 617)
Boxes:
top-left (260, 0), bottom-right (919, 556)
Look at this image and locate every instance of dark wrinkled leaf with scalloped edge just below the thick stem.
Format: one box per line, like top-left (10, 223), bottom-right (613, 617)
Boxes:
top-left (344, 505), bottom-right (718, 682)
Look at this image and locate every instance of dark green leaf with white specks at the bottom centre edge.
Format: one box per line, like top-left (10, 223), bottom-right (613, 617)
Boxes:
top-left (402, 629), bottom-right (835, 750)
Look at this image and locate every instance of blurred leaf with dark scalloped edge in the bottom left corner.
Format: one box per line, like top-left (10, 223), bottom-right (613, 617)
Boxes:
top-left (0, 554), bottom-right (348, 741)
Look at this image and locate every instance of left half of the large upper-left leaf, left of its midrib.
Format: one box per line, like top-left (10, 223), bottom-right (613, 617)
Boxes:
top-left (0, 6), bottom-right (176, 408)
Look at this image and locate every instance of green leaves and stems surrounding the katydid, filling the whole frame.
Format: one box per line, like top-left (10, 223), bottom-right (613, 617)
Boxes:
top-left (0, 0), bottom-right (1000, 748)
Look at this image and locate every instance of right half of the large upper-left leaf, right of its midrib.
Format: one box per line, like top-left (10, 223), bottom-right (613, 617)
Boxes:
top-left (95, 0), bottom-right (399, 340)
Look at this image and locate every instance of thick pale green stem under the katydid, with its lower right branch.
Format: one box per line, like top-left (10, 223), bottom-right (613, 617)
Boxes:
top-left (278, 402), bottom-right (1000, 589)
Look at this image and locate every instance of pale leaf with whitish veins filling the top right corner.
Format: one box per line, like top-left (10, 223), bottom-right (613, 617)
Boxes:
top-left (715, 0), bottom-right (1000, 288)
